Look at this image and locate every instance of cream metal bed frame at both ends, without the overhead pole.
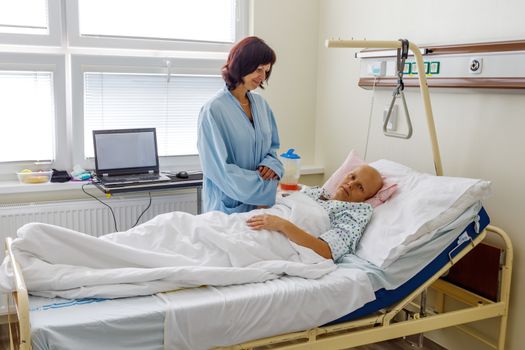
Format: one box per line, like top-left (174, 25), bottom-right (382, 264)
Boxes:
top-left (6, 225), bottom-right (513, 350)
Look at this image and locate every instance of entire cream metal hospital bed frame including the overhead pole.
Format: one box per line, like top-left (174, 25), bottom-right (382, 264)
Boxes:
top-left (6, 40), bottom-right (513, 350)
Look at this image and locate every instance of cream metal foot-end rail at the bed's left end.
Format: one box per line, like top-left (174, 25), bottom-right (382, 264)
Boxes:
top-left (6, 237), bottom-right (32, 350)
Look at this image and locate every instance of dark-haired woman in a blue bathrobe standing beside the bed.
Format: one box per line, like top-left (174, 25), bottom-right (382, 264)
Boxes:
top-left (197, 36), bottom-right (283, 214)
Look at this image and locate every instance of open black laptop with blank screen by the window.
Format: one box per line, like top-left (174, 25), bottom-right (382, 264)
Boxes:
top-left (93, 128), bottom-right (170, 187)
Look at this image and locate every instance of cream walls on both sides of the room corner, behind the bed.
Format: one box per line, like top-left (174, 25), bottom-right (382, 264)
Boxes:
top-left (252, 0), bottom-right (525, 350)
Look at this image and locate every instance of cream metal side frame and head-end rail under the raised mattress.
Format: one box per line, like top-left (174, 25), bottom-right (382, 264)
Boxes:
top-left (215, 225), bottom-right (513, 350)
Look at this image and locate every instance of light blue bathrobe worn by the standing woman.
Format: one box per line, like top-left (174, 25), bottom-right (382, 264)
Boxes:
top-left (197, 86), bottom-right (283, 214)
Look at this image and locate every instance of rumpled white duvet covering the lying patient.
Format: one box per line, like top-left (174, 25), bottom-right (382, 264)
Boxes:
top-left (0, 193), bottom-right (335, 299)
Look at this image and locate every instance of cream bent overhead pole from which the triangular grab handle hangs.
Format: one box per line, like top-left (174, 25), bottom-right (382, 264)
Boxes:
top-left (326, 40), bottom-right (443, 176)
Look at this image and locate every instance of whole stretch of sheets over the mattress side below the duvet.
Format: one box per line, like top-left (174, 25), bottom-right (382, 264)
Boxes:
top-left (30, 268), bottom-right (374, 350)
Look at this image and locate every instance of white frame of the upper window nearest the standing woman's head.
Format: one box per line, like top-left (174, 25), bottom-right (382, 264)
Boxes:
top-left (66, 0), bottom-right (250, 52)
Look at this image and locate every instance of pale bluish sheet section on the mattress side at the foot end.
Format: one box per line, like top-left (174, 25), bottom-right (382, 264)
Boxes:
top-left (29, 296), bottom-right (166, 350)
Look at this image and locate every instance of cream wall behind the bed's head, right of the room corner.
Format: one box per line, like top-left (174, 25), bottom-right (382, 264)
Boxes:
top-left (315, 0), bottom-right (525, 350)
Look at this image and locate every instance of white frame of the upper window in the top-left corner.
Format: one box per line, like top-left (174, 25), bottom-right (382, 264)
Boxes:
top-left (0, 0), bottom-right (63, 46)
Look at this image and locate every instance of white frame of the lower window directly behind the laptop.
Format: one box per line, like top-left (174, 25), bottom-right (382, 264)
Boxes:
top-left (71, 54), bottom-right (225, 170)
